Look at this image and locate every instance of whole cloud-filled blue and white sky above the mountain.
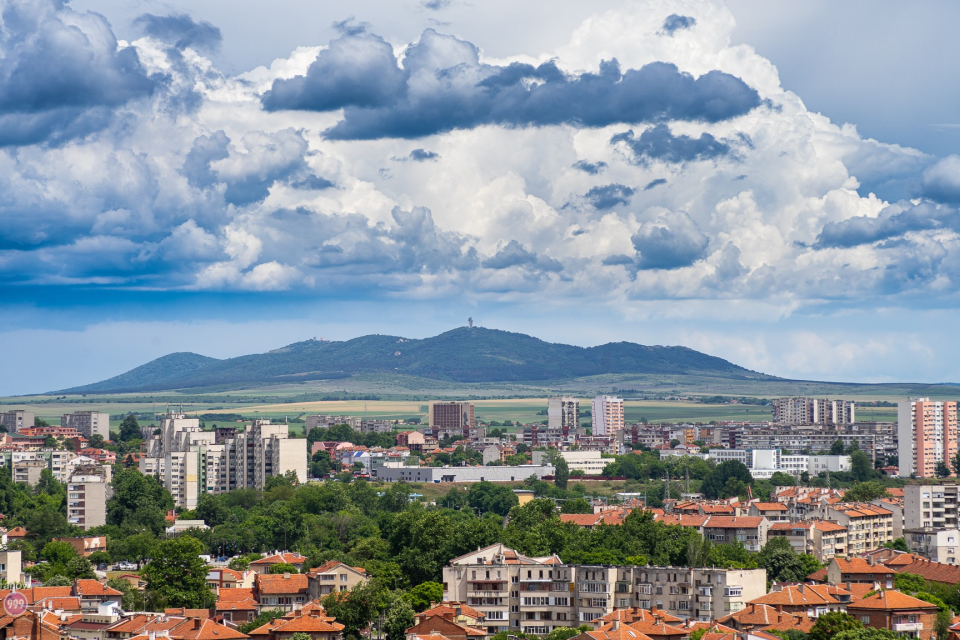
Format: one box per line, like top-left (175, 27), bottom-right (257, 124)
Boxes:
top-left (0, 0), bottom-right (960, 395)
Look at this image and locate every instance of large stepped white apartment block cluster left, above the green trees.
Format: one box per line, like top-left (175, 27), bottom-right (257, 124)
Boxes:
top-left (139, 413), bottom-right (307, 509)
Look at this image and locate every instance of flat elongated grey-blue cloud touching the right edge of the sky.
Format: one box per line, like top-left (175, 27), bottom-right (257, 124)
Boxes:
top-left (813, 201), bottom-right (960, 249)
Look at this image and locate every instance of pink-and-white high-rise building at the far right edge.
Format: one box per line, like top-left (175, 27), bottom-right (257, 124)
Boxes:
top-left (897, 398), bottom-right (957, 478)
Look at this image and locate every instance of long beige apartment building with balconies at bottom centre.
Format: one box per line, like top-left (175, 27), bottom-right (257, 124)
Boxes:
top-left (443, 544), bottom-right (766, 635)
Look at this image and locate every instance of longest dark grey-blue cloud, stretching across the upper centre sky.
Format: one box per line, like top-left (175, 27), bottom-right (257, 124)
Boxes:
top-left (262, 29), bottom-right (760, 140)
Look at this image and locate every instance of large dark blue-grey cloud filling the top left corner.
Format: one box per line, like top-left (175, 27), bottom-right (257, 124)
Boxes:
top-left (0, 0), bottom-right (158, 146)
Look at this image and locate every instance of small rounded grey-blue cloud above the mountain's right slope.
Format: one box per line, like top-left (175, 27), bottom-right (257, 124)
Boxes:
top-left (630, 211), bottom-right (709, 269)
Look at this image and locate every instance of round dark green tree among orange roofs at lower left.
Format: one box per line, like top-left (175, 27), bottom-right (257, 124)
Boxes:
top-left (141, 535), bottom-right (216, 610)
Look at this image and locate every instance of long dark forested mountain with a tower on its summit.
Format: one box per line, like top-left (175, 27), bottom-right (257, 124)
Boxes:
top-left (57, 327), bottom-right (775, 393)
